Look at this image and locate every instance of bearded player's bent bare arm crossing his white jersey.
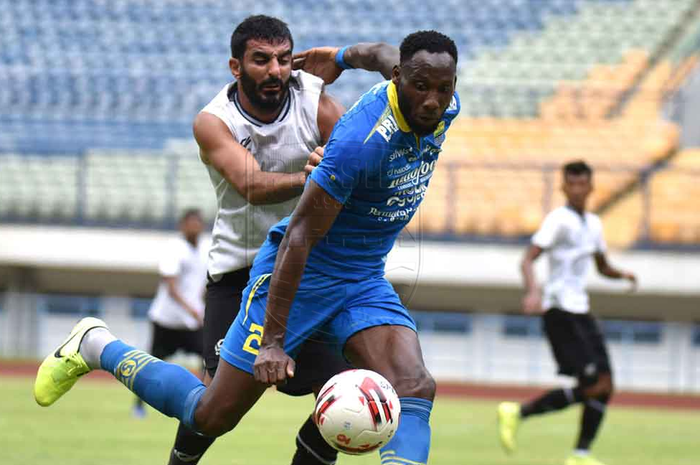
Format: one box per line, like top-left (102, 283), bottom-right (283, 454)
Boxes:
top-left (194, 113), bottom-right (306, 205)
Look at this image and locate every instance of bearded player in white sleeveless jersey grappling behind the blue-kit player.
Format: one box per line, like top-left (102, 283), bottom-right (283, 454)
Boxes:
top-left (169, 15), bottom-right (398, 465)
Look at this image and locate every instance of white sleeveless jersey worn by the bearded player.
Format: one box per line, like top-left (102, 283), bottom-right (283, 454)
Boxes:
top-left (202, 71), bottom-right (323, 280)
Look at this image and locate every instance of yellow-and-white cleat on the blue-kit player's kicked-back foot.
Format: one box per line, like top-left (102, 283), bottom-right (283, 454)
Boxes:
top-left (34, 317), bottom-right (107, 407)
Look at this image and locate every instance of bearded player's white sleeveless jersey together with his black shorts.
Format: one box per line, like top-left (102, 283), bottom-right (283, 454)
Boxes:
top-left (196, 71), bottom-right (347, 388)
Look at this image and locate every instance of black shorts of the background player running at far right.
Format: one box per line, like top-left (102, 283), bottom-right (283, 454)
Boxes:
top-left (543, 308), bottom-right (611, 384)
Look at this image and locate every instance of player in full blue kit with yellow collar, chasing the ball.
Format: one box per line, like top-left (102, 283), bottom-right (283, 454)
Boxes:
top-left (35, 31), bottom-right (460, 465)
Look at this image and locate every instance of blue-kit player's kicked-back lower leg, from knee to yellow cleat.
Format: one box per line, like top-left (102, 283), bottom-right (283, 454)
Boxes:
top-left (34, 318), bottom-right (266, 436)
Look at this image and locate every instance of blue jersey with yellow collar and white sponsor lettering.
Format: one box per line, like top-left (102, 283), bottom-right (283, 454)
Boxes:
top-left (251, 81), bottom-right (460, 280)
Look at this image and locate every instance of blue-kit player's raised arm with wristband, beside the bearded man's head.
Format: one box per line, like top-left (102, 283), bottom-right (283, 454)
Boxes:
top-left (293, 42), bottom-right (399, 85)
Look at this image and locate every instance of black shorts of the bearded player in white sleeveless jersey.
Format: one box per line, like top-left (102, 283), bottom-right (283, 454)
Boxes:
top-left (204, 268), bottom-right (352, 396)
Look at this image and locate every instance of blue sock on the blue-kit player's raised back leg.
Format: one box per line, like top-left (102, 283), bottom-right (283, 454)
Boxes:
top-left (100, 340), bottom-right (206, 431)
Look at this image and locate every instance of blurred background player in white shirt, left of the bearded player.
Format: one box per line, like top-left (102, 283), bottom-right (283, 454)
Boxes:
top-left (134, 209), bottom-right (208, 416)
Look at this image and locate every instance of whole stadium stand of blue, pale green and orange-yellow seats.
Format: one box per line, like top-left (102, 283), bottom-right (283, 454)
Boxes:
top-left (0, 0), bottom-right (698, 245)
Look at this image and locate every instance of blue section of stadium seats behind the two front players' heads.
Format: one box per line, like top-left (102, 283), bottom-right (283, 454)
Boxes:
top-left (0, 0), bottom-right (664, 153)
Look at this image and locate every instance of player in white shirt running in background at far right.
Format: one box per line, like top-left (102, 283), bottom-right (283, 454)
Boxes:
top-left (498, 161), bottom-right (637, 465)
